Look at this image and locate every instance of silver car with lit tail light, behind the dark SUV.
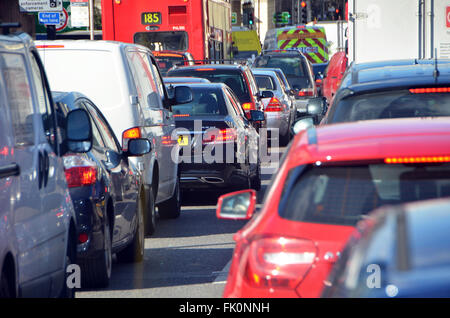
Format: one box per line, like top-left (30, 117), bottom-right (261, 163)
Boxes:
top-left (252, 69), bottom-right (295, 146)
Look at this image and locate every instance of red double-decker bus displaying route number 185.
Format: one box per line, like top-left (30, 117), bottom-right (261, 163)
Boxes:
top-left (102, 0), bottom-right (232, 60)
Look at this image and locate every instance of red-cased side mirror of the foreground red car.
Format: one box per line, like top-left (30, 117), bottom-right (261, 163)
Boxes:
top-left (216, 189), bottom-right (256, 220)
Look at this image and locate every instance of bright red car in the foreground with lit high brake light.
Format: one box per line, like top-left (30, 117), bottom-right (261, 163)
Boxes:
top-left (216, 117), bottom-right (450, 298)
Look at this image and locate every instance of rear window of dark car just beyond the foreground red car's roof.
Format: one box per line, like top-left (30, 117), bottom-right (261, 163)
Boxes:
top-left (328, 90), bottom-right (450, 123)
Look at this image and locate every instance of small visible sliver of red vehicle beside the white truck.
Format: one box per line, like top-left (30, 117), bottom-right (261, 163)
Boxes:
top-left (322, 51), bottom-right (348, 104)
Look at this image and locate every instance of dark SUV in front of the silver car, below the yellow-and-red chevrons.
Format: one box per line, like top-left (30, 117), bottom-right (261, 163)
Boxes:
top-left (252, 49), bottom-right (318, 108)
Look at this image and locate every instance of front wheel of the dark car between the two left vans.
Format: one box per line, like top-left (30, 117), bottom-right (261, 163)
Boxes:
top-left (117, 193), bottom-right (145, 263)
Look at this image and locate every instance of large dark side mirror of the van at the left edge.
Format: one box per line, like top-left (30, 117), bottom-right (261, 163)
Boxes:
top-left (66, 109), bottom-right (92, 153)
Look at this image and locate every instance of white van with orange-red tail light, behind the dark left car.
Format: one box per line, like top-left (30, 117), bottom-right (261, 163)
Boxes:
top-left (36, 40), bottom-right (190, 234)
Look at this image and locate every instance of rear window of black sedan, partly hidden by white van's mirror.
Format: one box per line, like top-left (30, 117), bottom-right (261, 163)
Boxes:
top-left (172, 86), bottom-right (228, 118)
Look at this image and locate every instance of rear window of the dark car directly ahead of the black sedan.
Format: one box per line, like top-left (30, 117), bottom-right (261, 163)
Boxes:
top-left (167, 68), bottom-right (251, 103)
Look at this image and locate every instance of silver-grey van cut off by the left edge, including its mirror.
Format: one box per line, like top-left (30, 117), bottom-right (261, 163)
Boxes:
top-left (0, 28), bottom-right (92, 298)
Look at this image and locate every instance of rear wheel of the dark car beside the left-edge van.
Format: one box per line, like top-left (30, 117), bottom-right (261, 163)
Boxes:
top-left (80, 212), bottom-right (112, 288)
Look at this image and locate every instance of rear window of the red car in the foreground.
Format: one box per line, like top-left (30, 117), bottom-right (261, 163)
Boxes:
top-left (279, 164), bottom-right (450, 226)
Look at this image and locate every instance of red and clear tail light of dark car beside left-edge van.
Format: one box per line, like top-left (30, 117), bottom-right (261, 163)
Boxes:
top-left (63, 155), bottom-right (97, 188)
